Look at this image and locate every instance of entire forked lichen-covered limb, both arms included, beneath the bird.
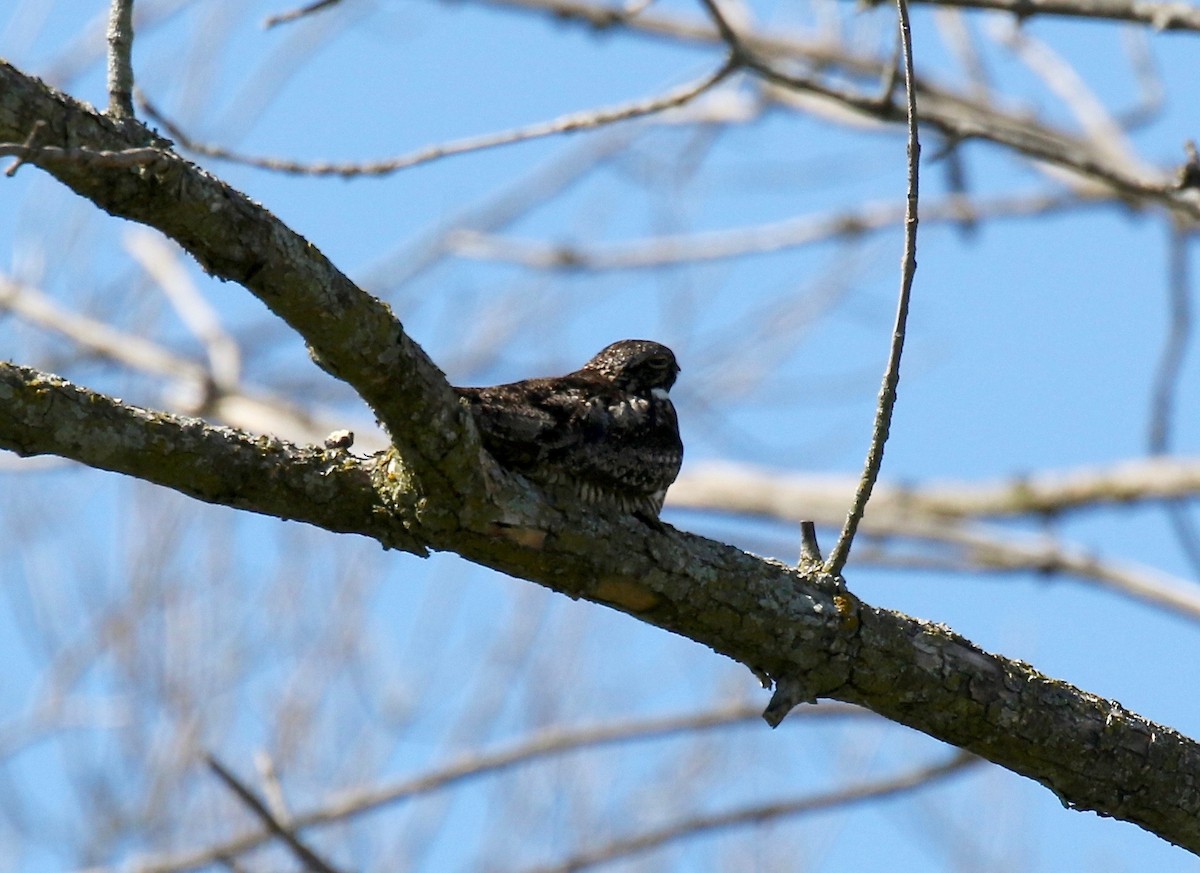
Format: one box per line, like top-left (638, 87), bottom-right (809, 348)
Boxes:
top-left (0, 62), bottom-right (1200, 854)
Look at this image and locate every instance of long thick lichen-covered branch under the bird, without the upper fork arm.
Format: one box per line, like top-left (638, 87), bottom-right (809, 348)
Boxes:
top-left (0, 365), bottom-right (1200, 853)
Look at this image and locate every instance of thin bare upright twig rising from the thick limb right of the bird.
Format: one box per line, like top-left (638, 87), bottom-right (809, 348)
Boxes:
top-left (826, 0), bottom-right (920, 576)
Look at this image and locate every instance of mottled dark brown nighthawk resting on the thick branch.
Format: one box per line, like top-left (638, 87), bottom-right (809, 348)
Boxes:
top-left (455, 339), bottom-right (683, 518)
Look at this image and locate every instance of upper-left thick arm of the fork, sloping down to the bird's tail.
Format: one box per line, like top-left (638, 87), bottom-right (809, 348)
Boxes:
top-left (0, 61), bottom-right (486, 522)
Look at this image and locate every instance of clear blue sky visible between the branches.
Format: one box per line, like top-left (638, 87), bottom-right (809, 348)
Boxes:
top-left (0, 0), bottom-right (1200, 871)
